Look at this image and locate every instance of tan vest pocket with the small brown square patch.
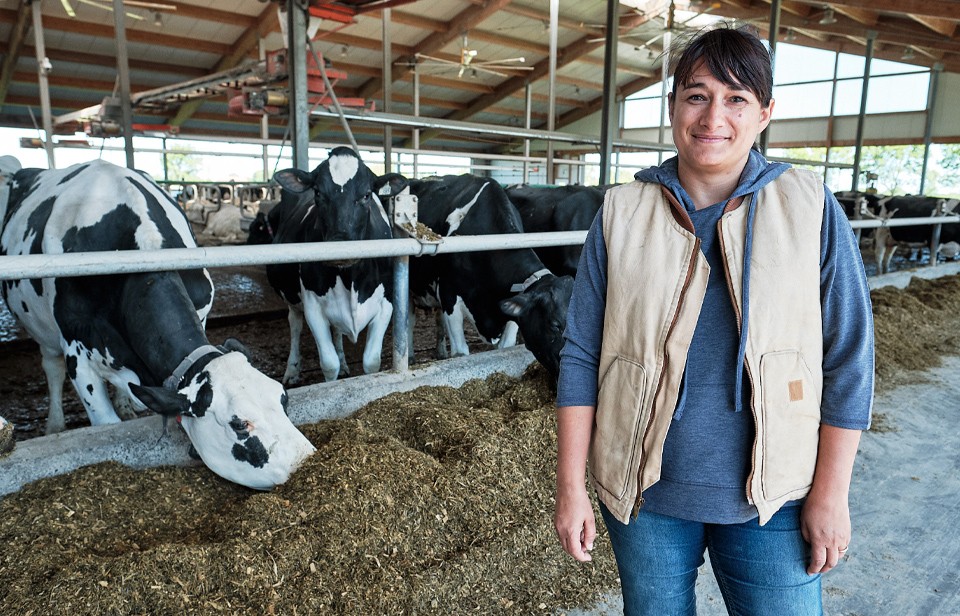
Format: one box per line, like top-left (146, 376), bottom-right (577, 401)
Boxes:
top-left (759, 350), bottom-right (821, 500)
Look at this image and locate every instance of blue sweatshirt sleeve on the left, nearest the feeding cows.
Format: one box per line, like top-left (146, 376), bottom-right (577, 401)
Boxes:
top-left (557, 207), bottom-right (607, 407)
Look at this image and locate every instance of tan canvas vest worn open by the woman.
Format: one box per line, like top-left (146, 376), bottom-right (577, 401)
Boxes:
top-left (590, 169), bottom-right (824, 524)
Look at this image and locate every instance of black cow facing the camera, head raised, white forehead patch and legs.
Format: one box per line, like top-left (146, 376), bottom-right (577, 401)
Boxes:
top-left (265, 147), bottom-right (406, 383)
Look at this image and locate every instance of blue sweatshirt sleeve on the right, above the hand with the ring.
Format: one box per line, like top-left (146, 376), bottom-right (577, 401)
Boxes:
top-left (820, 189), bottom-right (874, 430)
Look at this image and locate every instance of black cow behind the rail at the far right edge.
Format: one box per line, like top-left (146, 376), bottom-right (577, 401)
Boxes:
top-left (872, 195), bottom-right (960, 273)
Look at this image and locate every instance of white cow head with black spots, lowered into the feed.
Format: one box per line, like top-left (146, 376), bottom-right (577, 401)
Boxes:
top-left (130, 352), bottom-right (314, 490)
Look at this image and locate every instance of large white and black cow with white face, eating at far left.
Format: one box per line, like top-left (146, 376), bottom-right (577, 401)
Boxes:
top-left (0, 161), bottom-right (314, 489)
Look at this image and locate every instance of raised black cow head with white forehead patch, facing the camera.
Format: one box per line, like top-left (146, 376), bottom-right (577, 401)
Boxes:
top-left (273, 147), bottom-right (407, 260)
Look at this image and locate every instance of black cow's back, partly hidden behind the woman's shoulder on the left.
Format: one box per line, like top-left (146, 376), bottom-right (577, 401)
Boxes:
top-left (506, 184), bottom-right (603, 276)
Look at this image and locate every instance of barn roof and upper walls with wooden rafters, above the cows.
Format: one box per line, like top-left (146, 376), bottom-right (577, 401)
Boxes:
top-left (0, 0), bottom-right (960, 190)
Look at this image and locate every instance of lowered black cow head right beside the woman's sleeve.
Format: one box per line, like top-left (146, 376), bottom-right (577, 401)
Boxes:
top-left (500, 274), bottom-right (573, 382)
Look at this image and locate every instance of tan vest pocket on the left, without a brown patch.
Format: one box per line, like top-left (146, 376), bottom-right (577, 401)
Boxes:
top-left (590, 357), bottom-right (649, 500)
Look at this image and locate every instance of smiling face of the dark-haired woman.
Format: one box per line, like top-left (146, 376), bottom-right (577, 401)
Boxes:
top-left (670, 61), bottom-right (773, 175)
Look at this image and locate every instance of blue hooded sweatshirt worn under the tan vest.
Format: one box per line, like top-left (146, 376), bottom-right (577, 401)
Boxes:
top-left (557, 151), bottom-right (874, 524)
